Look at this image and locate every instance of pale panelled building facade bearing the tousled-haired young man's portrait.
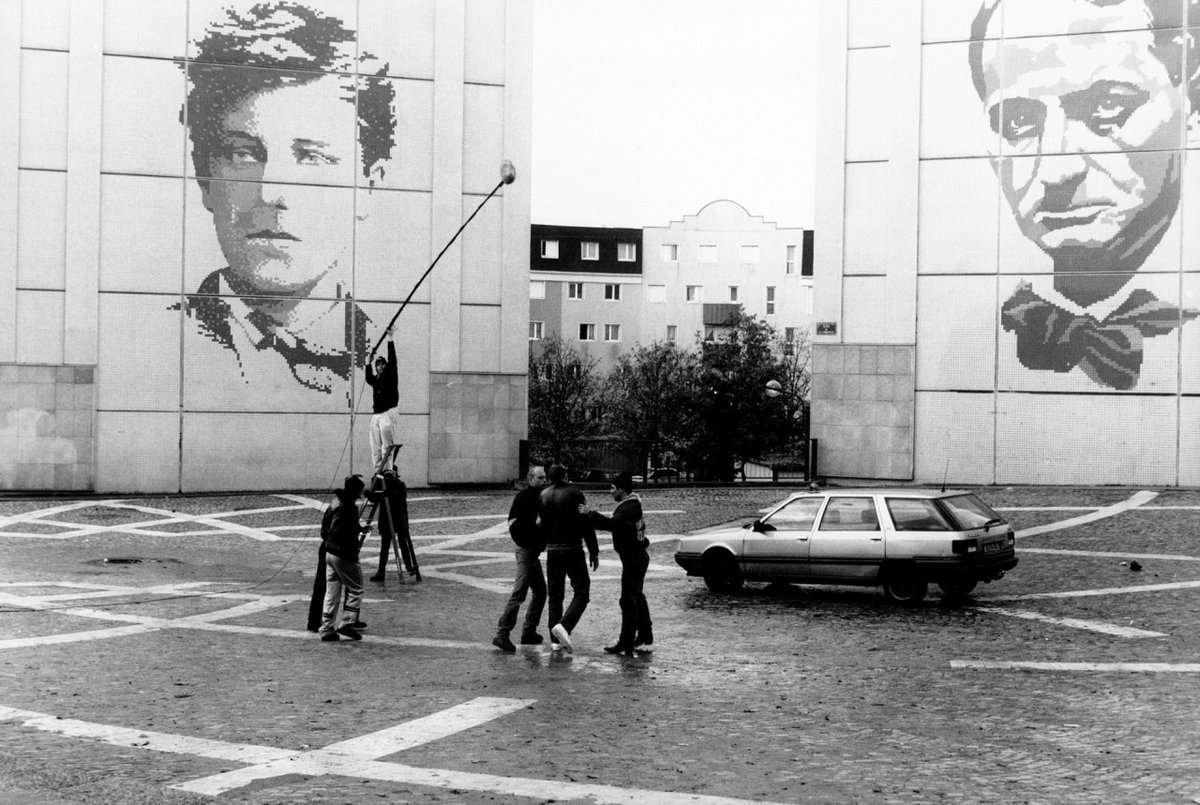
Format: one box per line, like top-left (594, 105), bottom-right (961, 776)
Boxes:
top-left (0, 0), bottom-right (533, 492)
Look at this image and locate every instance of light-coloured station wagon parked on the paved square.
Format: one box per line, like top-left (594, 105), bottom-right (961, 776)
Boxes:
top-left (676, 488), bottom-right (1016, 603)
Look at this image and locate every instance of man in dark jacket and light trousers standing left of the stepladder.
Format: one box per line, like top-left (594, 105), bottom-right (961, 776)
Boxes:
top-left (318, 475), bottom-right (370, 643)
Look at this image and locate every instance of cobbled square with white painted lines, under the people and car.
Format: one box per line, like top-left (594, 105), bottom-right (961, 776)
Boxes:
top-left (0, 487), bottom-right (1200, 805)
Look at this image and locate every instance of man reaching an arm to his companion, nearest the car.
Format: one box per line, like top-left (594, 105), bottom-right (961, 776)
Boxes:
top-left (588, 473), bottom-right (654, 655)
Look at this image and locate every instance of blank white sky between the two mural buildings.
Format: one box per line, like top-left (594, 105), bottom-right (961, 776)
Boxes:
top-left (529, 0), bottom-right (817, 228)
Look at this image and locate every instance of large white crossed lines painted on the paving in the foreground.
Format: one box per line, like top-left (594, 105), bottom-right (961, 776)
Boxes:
top-left (0, 698), bottom-right (780, 805)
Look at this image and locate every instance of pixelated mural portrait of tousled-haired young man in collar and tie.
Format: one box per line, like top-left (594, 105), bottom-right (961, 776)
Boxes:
top-left (180, 2), bottom-right (396, 410)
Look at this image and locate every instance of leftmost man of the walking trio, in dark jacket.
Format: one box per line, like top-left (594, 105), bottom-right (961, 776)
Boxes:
top-left (492, 467), bottom-right (546, 653)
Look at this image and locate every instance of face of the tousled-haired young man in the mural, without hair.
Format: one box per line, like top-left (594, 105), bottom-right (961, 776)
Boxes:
top-left (203, 77), bottom-right (356, 296)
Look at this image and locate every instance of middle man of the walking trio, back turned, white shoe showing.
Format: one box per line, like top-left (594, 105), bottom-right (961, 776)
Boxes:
top-left (538, 464), bottom-right (600, 651)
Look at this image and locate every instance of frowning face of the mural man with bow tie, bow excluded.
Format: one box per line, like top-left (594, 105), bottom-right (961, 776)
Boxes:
top-left (982, 0), bottom-right (1186, 292)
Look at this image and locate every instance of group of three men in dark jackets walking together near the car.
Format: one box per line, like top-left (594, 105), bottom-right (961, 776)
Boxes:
top-left (492, 464), bottom-right (654, 655)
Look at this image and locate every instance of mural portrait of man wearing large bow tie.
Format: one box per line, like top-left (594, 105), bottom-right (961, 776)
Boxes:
top-left (968, 0), bottom-right (1200, 391)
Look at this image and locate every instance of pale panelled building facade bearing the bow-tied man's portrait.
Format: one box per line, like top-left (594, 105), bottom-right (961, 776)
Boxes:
top-left (812, 0), bottom-right (1200, 486)
